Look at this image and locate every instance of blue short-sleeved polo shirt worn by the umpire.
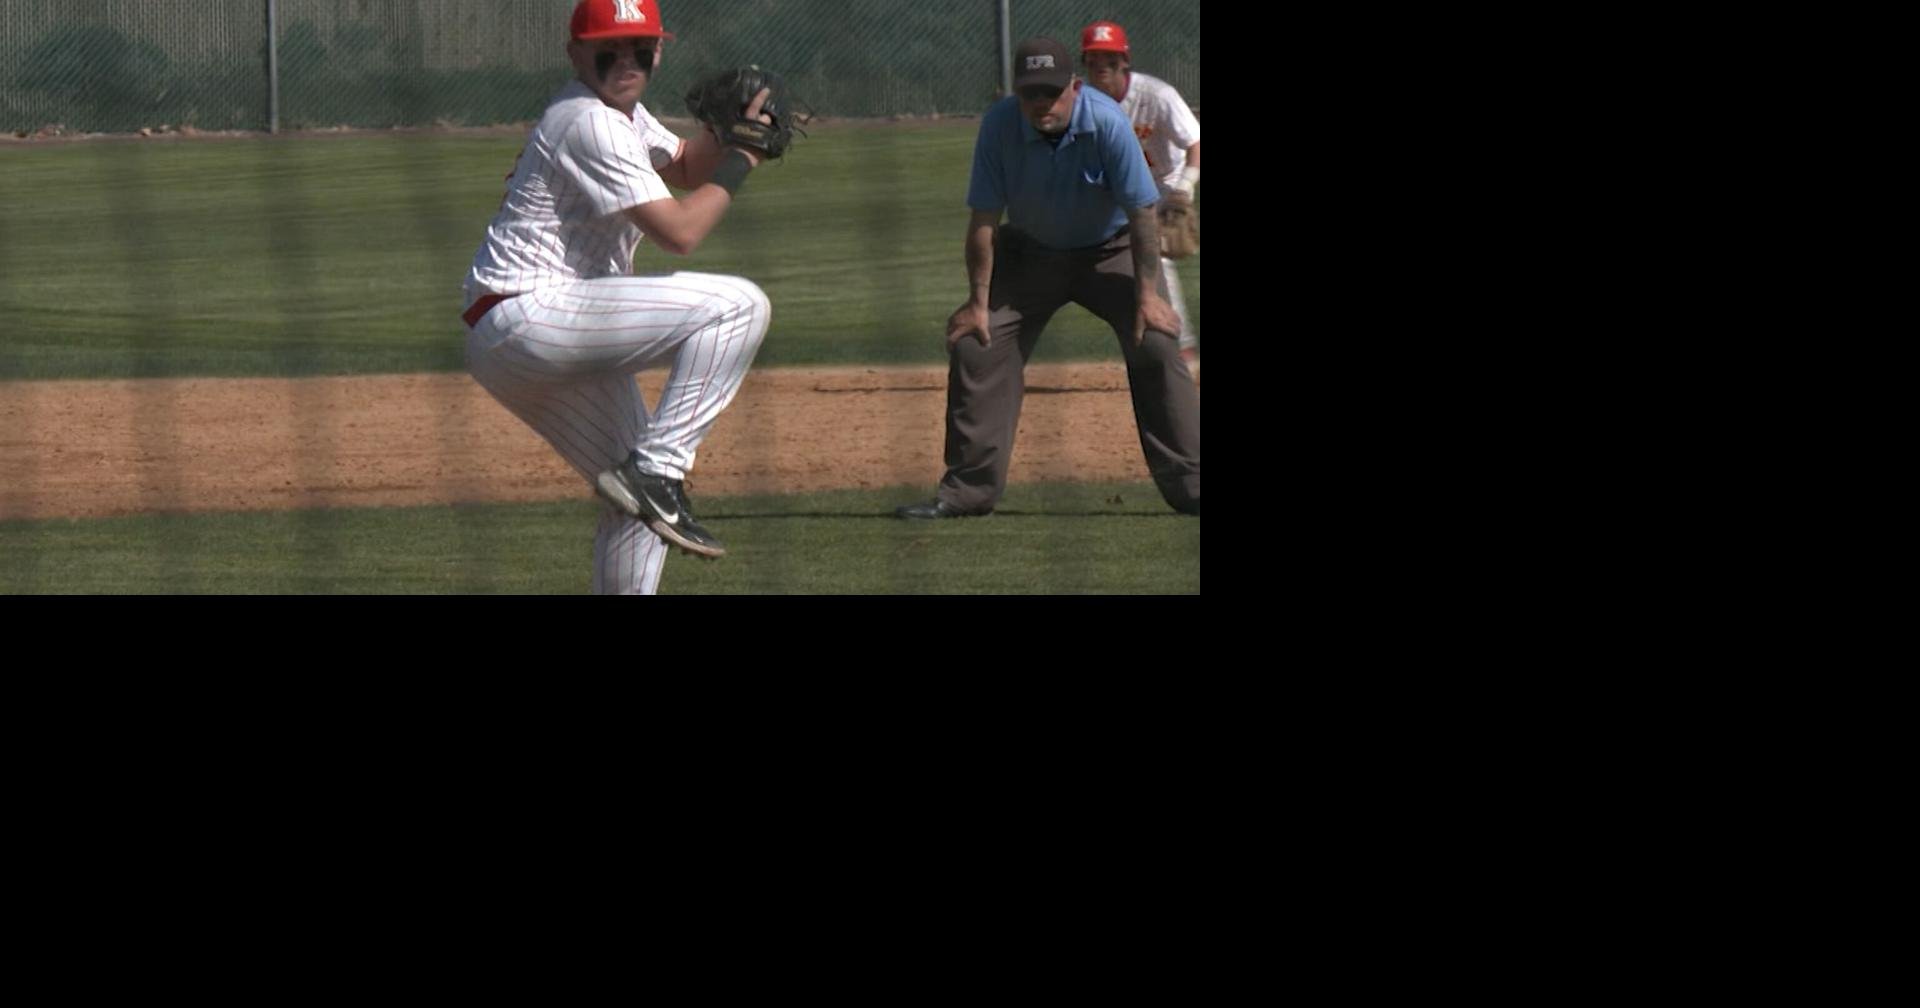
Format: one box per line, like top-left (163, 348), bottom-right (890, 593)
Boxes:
top-left (966, 83), bottom-right (1160, 248)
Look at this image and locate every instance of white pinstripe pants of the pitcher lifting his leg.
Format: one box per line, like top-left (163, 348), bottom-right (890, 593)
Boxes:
top-left (467, 273), bottom-right (772, 595)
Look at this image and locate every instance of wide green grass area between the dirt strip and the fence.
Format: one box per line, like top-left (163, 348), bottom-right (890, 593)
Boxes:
top-left (0, 119), bottom-right (1200, 380)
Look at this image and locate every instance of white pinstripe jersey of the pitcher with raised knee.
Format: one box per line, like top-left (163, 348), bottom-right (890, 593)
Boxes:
top-left (467, 81), bottom-right (682, 301)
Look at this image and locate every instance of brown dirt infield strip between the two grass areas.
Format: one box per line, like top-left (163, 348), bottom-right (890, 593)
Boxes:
top-left (0, 361), bottom-right (1198, 520)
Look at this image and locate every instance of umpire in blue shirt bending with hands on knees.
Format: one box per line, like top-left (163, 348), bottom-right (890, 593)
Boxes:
top-left (895, 38), bottom-right (1200, 518)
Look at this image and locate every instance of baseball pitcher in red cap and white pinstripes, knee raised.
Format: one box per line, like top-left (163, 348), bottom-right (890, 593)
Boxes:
top-left (463, 0), bottom-right (795, 595)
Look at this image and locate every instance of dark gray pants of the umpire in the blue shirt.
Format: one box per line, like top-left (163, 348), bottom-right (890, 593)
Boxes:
top-left (939, 227), bottom-right (1200, 513)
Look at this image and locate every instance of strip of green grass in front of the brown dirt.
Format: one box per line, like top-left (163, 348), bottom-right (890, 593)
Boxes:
top-left (0, 482), bottom-right (1200, 595)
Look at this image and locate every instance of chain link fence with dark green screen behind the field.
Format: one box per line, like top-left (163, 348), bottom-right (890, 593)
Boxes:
top-left (0, 0), bottom-right (1200, 134)
